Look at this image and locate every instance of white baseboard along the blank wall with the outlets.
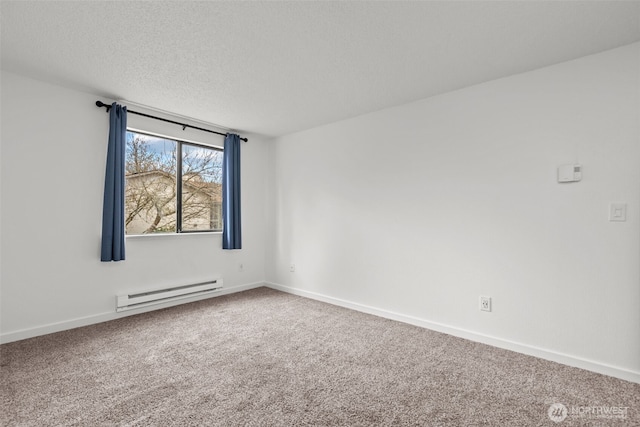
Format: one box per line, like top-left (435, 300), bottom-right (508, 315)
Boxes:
top-left (265, 282), bottom-right (640, 384)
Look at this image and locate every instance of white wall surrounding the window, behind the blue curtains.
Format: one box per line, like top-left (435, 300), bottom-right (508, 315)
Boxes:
top-left (0, 72), bottom-right (268, 342)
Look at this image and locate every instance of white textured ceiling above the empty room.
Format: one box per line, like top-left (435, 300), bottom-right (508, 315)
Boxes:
top-left (0, 0), bottom-right (640, 136)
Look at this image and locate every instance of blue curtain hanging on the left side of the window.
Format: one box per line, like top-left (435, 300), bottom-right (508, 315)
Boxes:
top-left (100, 102), bottom-right (127, 262)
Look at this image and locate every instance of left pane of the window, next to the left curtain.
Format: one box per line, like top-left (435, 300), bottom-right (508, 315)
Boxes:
top-left (125, 132), bottom-right (176, 234)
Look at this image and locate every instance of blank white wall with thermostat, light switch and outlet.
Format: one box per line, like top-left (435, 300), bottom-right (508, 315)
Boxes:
top-left (267, 43), bottom-right (640, 381)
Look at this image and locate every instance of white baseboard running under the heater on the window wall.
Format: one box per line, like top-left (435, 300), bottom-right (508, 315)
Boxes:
top-left (0, 282), bottom-right (265, 344)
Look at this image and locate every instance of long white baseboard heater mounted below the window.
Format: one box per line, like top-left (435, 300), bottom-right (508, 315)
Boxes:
top-left (116, 279), bottom-right (222, 311)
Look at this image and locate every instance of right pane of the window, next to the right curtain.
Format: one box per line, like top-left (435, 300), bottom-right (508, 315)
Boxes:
top-left (182, 143), bottom-right (222, 231)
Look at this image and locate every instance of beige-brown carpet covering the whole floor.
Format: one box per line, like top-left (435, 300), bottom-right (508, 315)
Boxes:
top-left (0, 288), bottom-right (640, 427)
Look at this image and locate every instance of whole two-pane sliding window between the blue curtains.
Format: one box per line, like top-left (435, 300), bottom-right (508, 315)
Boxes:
top-left (125, 131), bottom-right (222, 235)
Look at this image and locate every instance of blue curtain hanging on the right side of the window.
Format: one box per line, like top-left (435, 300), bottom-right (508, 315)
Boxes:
top-left (222, 133), bottom-right (242, 249)
